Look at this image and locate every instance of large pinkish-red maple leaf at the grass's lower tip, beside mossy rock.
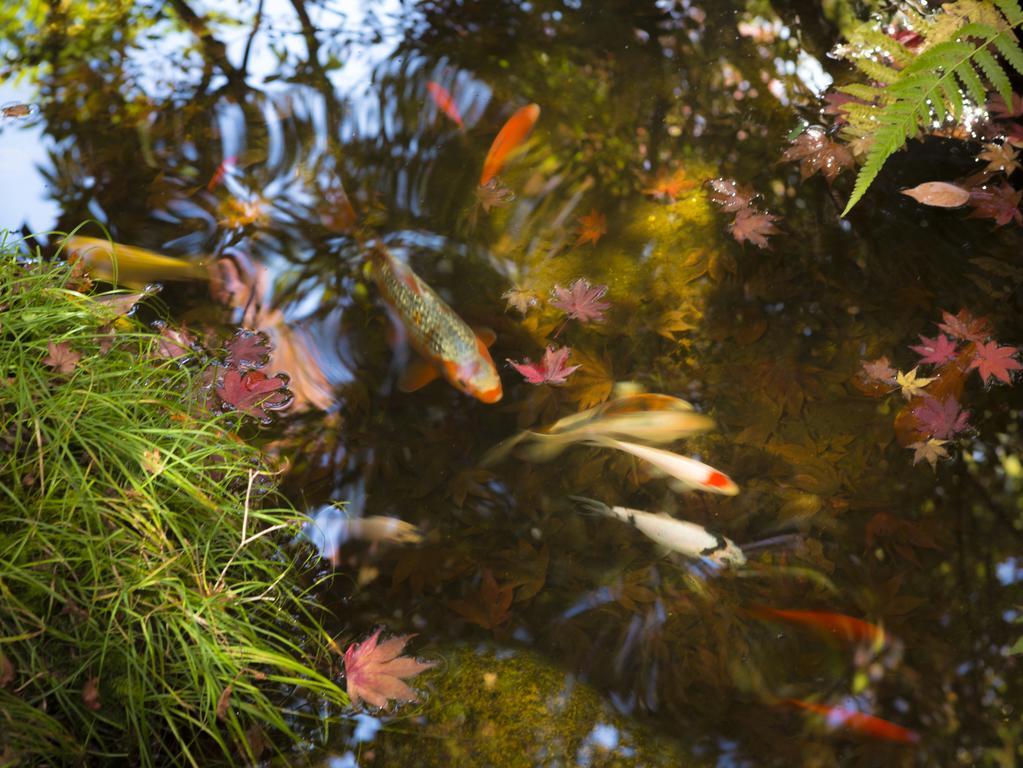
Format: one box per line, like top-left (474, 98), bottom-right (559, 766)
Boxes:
top-left (345, 630), bottom-right (435, 708)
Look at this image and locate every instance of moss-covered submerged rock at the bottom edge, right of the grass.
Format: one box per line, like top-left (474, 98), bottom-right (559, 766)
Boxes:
top-left (322, 645), bottom-right (698, 768)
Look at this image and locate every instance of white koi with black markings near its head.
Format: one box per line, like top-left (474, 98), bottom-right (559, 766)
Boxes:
top-left (569, 496), bottom-right (746, 566)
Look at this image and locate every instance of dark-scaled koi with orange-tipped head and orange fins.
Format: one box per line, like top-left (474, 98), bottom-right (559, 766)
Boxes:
top-left (369, 244), bottom-right (503, 403)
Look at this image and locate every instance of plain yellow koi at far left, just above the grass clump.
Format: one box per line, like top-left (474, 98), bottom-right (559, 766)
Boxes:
top-left (64, 235), bottom-right (208, 287)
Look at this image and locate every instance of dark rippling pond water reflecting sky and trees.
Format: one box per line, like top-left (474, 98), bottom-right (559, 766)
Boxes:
top-left (0, 0), bottom-right (1023, 766)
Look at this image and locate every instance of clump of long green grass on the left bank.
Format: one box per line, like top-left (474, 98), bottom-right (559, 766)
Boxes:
top-left (0, 241), bottom-right (347, 765)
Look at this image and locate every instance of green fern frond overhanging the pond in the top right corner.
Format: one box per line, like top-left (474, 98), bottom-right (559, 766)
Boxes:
top-left (840, 0), bottom-right (1023, 216)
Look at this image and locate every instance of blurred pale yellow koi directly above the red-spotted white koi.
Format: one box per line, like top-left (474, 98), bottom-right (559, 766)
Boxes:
top-left (484, 393), bottom-right (714, 465)
